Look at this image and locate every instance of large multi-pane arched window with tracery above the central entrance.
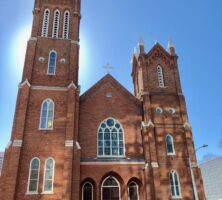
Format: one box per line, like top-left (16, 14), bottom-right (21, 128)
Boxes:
top-left (98, 118), bottom-right (125, 157)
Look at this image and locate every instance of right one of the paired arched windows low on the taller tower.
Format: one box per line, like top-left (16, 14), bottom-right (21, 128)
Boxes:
top-left (43, 158), bottom-right (55, 193)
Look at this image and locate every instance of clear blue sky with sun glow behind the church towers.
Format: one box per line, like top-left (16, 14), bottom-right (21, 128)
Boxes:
top-left (0, 0), bottom-right (222, 160)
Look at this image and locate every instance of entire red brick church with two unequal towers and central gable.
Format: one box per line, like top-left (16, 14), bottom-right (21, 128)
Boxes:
top-left (0, 0), bottom-right (205, 200)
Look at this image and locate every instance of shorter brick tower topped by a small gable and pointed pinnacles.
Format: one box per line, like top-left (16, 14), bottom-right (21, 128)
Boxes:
top-left (132, 39), bottom-right (205, 200)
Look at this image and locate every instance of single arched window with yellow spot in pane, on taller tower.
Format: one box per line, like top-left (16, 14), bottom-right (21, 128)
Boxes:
top-left (39, 99), bottom-right (54, 129)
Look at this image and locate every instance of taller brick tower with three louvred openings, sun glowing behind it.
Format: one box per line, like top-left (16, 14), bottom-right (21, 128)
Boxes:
top-left (0, 0), bottom-right (80, 200)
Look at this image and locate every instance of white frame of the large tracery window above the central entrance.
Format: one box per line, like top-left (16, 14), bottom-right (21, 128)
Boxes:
top-left (97, 117), bottom-right (126, 158)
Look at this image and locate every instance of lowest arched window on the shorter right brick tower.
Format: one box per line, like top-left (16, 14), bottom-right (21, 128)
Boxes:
top-left (170, 171), bottom-right (181, 197)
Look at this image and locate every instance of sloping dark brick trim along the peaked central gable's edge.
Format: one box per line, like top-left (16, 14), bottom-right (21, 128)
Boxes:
top-left (80, 74), bottom-right (141, 105)
